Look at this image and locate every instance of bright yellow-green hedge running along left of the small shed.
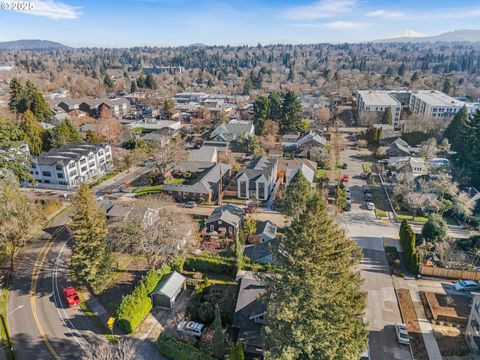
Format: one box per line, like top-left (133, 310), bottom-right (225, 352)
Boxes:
top-left (115, 266), bottom-right (172, 333)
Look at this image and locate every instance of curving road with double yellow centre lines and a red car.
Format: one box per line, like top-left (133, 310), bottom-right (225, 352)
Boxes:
top-left (8, 210), bottom-right (101, 360)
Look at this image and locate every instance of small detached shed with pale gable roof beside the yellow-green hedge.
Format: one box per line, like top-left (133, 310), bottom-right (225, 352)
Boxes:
top-left (150, 271), bottom-right (186, 309)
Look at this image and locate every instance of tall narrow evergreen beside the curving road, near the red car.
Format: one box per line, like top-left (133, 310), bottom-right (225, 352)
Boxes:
top-left (68, 184), bottom-right (111, 284)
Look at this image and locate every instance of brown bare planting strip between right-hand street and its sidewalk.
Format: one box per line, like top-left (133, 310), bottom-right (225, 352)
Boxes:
top-left (397, 289), bottom-right (428, 360)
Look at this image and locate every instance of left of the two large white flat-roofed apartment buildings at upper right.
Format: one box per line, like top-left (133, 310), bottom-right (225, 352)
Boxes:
top-left (357, 90), bottom-right (402, 127)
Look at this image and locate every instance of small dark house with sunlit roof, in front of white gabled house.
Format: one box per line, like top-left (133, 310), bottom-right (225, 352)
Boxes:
top-left (203, 204), bottom-right (245, 238)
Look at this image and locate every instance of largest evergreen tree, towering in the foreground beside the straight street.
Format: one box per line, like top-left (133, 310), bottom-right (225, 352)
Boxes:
top-left (263, 192), bottom-right (367, 360)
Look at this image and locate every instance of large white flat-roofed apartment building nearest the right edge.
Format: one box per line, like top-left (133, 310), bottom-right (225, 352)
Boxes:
top-left (409, 90), bottom-right (480, 120)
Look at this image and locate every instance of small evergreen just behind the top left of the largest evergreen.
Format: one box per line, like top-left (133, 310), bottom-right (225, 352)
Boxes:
top-left (280, 170), bottom-right (312, 217)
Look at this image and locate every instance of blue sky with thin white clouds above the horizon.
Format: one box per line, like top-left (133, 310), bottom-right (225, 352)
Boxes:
top-left (0, 0), bottom-right (480, 47)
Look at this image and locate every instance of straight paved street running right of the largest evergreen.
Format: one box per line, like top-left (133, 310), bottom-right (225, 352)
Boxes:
top-left (337, 131), bottom-right (411, 360)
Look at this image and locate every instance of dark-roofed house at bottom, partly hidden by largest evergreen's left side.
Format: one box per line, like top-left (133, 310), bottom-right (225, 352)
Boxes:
top-left (232, 277), bottom-right (267, 356)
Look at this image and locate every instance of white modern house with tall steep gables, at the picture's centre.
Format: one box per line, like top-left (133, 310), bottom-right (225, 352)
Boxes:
top-left (236, 156), bottom-right (278, 201)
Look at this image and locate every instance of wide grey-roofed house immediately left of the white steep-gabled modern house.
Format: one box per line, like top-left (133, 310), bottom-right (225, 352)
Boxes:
top-left (163, 161), bottom-right (232, 202)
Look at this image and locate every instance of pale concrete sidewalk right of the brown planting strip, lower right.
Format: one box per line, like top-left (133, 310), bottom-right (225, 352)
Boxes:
top-left (392, 276), bottom-right (442, 360)
